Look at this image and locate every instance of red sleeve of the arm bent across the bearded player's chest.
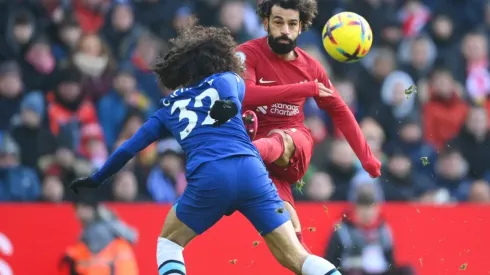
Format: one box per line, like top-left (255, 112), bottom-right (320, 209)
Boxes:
top-left (237, 45), bottom-right (319, 107)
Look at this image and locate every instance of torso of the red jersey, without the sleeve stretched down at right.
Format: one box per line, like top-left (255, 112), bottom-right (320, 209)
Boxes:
top-left (237, 37), bottom-right (328, 137)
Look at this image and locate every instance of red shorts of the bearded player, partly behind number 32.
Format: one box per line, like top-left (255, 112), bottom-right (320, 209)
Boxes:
top-left (267, 128), bottom-right (313, 206)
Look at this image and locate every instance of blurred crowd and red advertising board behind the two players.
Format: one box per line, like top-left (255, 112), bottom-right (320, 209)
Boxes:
top-left (0, 0), bottom-right (490, 275)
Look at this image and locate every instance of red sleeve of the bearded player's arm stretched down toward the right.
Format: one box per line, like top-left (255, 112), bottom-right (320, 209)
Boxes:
top-left (315, 69), bottom-right (374, 165)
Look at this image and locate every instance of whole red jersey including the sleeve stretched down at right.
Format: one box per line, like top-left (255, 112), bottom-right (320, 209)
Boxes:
top-left (237, 37), bottom-right (379, 172)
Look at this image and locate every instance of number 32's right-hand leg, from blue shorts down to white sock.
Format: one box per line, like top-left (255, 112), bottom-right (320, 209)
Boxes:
top-left (238, 162), bottom-right (340, 275)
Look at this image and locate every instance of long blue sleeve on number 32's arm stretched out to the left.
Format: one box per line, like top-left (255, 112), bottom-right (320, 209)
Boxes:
top-left (92, 115), bottom-right (166, 184)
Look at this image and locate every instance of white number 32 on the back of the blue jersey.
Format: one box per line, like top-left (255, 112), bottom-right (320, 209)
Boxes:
top-left (170, 88), bottom-right (219, 140)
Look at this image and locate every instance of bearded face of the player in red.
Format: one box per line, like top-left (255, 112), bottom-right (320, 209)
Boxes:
top-left (264, 5), bottom-right (301, 55)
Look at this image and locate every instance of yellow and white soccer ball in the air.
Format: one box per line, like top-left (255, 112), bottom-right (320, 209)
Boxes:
top-left (322, 12), bottom-right (373, 63)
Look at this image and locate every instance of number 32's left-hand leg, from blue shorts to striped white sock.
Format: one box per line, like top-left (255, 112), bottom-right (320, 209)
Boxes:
top-left (157, 160), bottom-right (236, 275)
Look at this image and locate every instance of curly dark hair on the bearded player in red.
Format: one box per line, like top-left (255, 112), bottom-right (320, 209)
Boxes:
top-left (257, 0), bottom-right (318, 31)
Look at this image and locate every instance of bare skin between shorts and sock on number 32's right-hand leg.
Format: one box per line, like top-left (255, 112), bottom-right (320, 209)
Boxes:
top-left (264, 219), bottom-right (308, 274)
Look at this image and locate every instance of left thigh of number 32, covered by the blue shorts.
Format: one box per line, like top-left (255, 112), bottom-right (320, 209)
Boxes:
top-left (174, 159), bottom-right (236, 235)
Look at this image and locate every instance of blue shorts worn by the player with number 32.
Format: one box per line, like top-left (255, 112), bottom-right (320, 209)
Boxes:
top-left (174, 156), bottom-right (289, 235)
